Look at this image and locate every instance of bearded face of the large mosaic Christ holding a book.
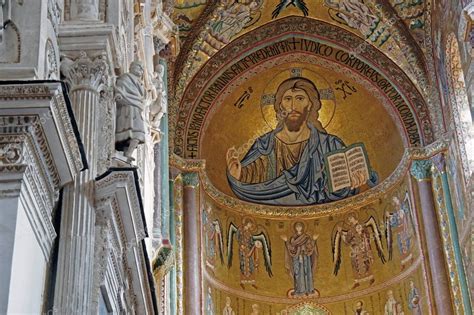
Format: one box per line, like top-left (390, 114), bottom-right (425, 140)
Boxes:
top-left (280, 89), bottom-right (311, 131)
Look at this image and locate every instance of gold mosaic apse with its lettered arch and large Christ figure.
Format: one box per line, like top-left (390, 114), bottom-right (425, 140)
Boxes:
top-left (171, 17), bottom-right (468, 314)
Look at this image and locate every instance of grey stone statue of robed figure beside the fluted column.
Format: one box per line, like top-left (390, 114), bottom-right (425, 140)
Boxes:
top-left (115, 61), bottom-right (146, 158)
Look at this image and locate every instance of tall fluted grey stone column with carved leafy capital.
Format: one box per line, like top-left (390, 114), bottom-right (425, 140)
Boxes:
top-left (54, 52), bottom-right (108, 314)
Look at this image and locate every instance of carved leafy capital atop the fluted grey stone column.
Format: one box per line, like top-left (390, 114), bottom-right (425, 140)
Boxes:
top-left (61, 51), bottom-right (110, 93)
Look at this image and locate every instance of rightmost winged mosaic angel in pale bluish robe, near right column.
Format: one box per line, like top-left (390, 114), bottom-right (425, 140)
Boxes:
top-left (385, 193), bottom-right (413, 270)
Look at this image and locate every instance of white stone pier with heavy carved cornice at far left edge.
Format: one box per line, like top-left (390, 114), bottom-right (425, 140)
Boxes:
top-left (0, 82), bottom-right (83, 314)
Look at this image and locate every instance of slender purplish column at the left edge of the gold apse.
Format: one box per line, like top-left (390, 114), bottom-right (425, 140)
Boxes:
top-left (183, 173), bottom-right (202, 315)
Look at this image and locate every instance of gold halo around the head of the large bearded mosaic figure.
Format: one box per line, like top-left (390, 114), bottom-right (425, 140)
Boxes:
top-left (260, 67), bottom-right (336, 129)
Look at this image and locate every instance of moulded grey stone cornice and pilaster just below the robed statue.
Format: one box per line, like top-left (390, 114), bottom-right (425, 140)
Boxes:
top-left (92, 168), bottom-right (157, 314)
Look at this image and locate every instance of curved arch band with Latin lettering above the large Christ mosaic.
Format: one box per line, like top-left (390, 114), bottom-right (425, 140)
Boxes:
top-left (170, 16), bottom-right (434, 158)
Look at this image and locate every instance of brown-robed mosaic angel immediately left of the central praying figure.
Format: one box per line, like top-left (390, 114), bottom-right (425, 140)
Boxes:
top-left (227, 218), bottom-right (273, 289)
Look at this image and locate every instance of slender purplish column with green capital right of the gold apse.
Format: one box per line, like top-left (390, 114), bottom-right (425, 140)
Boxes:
top-left (411, 160), bottom-right (454, 315)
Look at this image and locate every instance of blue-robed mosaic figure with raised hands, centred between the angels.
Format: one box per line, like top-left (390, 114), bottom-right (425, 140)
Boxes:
top-left (281, 222), bottom-right (319, 297)
